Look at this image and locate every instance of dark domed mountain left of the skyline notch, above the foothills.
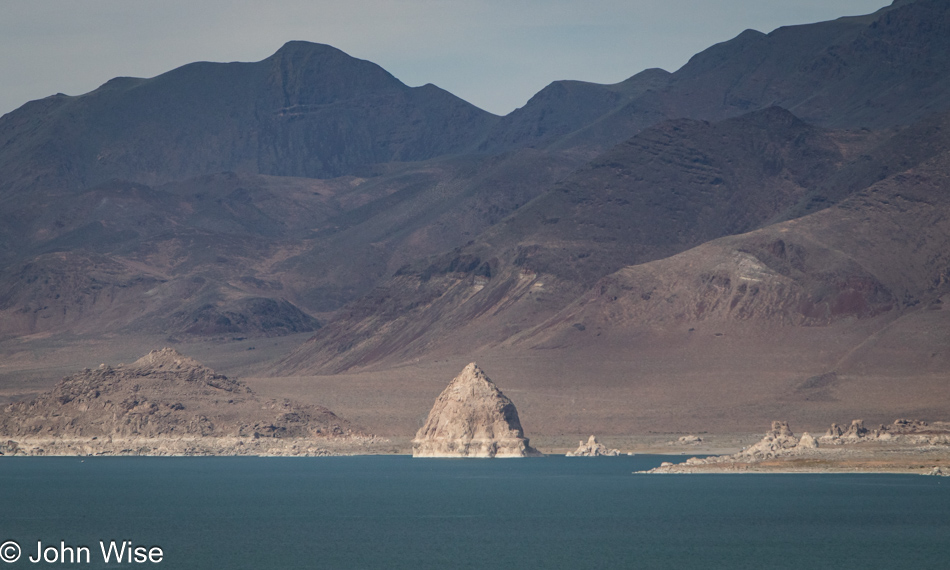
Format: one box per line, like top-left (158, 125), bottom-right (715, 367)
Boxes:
top-left (0, 42), bottom-right (497, 191)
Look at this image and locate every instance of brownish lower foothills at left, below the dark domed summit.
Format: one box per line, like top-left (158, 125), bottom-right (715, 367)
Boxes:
top-left (0, 151), bottom-right (574, 337)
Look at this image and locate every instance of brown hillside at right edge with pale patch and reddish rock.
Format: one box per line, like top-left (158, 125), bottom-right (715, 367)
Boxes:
top-left (539, 141), bottom-right (950, 340)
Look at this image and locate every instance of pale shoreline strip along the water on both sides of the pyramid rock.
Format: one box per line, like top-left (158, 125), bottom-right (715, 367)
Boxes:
top-left (0, 434), bottom-right (950, 475)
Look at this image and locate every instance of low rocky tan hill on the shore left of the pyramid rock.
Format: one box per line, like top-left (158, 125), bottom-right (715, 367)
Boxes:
top-left (0, 348), bottom-right (362, 455)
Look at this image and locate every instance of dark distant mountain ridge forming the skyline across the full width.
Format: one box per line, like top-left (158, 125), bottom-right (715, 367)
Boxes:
top-left (0, 0), bottom-right (950, 204)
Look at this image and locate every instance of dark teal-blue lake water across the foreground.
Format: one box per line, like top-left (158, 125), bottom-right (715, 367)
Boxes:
top-left (0, 456), bottom-right (950, 570)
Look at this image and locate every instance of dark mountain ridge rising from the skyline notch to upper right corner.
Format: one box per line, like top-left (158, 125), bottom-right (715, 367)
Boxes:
top-left (483, 0), bottom-right (950, 150)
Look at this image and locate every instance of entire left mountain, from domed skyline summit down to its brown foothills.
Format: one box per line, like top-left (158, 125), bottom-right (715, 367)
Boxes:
top-left (0, 42), bottom-right (579, 335)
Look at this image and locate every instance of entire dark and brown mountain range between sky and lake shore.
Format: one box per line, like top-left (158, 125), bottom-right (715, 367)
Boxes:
top-left (0, 0), bottom-right (950, 434)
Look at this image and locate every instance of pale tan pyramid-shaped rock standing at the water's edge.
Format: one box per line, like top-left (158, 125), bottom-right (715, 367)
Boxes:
top-left (412, 362), bottom-right (540, 457)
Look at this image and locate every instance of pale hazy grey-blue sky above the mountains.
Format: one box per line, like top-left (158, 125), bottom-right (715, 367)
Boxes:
top-left (0, 0), bottom-right (890, 115)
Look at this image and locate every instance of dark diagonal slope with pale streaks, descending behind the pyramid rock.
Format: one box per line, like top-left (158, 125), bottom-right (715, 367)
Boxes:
top-left (278, 108), bottom-right (868, 372)
